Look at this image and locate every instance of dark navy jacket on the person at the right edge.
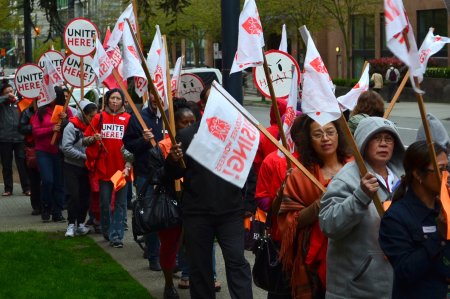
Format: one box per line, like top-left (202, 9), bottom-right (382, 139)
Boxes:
top-left (379, 188), bottom-right (450, 299)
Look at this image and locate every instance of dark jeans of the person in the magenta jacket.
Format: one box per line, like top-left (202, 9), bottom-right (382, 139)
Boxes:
top-left (36, 151), bottom-right (64, 217)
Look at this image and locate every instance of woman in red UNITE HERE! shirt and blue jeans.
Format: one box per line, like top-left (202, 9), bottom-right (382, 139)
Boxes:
top-left (83, 88), bottom-right (131, 248)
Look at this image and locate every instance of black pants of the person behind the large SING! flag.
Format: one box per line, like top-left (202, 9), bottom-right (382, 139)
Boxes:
top-left (183, 213), bottom-right (253, 299)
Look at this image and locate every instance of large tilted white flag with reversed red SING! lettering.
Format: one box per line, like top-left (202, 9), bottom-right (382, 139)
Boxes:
top-left (186, 84), bottom-right (259, 188)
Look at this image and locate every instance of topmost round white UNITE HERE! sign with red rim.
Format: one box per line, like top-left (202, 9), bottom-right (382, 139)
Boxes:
top-left (64, 18), bottom-right (99, 56)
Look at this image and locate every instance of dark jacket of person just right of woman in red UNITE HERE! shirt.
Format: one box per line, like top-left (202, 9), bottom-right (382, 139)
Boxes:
top-left (122, 107), bottom-right (163, 177)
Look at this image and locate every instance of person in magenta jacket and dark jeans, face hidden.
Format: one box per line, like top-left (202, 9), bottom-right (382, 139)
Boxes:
top-left (31, 87), bottom-right (72, 222)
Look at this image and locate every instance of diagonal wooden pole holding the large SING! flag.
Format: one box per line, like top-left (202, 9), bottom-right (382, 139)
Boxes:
top-left (212, 81), bottom-right (326, 193)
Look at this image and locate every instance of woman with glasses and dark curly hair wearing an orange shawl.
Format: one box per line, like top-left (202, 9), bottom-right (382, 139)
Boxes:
top-left (278, 115), bottom-right (349, 298)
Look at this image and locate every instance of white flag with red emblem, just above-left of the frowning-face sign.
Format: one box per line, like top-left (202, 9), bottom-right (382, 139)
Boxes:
top-left (230, 0), bottom-right (264, 75)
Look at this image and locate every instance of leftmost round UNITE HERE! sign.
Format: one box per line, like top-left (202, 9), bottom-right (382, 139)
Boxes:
top-left (14, 63), bottom-right (44, 99)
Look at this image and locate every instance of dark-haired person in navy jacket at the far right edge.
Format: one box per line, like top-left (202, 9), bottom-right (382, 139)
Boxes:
top-left (379, 141), bottom-right (450, 299)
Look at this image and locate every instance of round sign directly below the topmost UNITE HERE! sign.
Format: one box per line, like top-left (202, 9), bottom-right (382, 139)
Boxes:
top-left (62, 54), bottom-right (95, 87)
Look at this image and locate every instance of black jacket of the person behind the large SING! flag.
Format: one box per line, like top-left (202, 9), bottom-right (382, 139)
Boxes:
top-left (164, 122), bottom-right (256, 216)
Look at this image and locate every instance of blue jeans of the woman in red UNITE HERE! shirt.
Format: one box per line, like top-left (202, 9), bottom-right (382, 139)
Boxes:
top-left (100, 181), bottom-right (127, 242)
